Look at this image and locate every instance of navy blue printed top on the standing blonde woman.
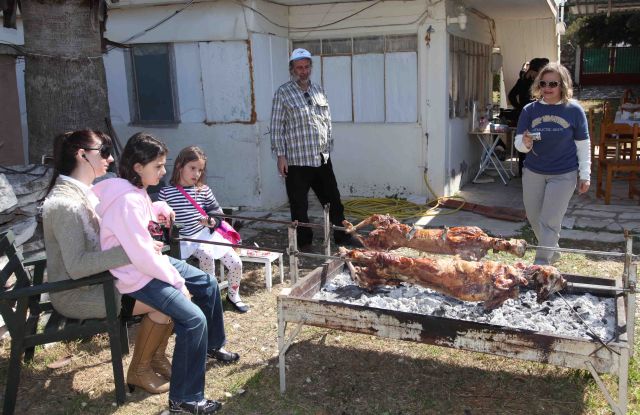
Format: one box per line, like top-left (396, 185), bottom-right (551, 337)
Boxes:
top-left (516, 100), bottom-right (589, 174)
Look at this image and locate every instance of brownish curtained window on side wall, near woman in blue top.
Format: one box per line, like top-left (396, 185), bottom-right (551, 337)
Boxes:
top-left (449, 35), bottom-right (491, 118)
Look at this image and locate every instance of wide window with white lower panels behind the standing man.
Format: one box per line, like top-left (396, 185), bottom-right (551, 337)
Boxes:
top-left (293, 34), bottom-right (418, 123)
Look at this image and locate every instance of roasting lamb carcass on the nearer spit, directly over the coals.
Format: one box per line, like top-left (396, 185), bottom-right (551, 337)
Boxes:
top-left (340, 248), bottom-right (566, 309)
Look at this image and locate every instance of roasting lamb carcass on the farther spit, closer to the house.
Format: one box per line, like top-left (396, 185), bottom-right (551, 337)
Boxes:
top-left (343, 215), bottom-right (527, 259)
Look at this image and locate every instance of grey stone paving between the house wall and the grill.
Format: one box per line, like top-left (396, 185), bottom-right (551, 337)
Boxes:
top-left (239, 172), bottom-right (640, 247)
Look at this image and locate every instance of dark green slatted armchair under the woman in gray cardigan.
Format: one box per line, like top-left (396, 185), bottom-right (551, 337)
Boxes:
top-left (0, 231), bottom-right (128, 415)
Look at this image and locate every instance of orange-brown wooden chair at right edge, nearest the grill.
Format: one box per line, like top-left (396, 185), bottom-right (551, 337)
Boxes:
top-left (596, 124), bottom-right (640, 205)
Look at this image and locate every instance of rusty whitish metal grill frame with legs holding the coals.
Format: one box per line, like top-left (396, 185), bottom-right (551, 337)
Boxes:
top-left (278, 260), bottom-right (635, 413)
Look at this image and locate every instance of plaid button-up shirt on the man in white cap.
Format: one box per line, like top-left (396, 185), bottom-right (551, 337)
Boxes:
top-left (271, 81), bottom-right (333, 167)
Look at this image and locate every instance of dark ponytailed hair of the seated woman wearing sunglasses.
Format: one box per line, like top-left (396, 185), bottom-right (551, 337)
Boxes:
top-left (45, 130), bottom-right (113, 196)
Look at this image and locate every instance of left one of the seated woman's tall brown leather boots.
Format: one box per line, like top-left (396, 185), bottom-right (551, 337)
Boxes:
top-left (127, 315), bottom-right (169, 393)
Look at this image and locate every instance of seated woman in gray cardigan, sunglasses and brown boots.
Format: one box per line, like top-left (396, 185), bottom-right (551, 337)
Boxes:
top-left (42, 130), bottom-right (173, 393)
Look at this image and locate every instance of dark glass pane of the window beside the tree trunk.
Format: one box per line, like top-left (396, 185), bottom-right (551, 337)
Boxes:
top-left (132, 44), bottom-right (175, 122)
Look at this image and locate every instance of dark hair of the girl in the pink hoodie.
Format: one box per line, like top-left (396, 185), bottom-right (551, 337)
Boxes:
top-left (118, 133), bottom-right (169, 189)
